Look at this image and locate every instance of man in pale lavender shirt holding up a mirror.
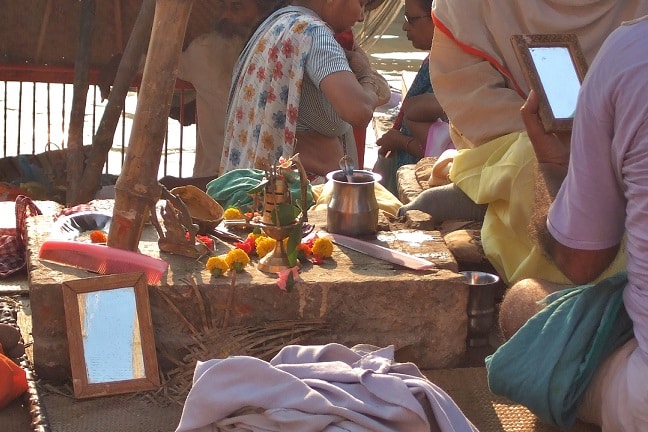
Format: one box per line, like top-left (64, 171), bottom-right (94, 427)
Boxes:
top-left (487, 16), bottom-right (648, 432)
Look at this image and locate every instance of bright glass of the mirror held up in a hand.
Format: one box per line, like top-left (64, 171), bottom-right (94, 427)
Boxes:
top-left (529, 46), bottom-right (580, 118)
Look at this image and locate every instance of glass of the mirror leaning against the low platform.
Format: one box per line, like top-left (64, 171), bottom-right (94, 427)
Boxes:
top-left (77, 287), bottom-right (145, 383)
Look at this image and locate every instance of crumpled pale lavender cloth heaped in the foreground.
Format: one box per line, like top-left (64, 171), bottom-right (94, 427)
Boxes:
top-left (176, 344), bottom-right (477, 432)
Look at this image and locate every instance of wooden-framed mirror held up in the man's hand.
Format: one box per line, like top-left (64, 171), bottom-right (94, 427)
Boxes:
top-left (511, 34), bottom-right (587, 132)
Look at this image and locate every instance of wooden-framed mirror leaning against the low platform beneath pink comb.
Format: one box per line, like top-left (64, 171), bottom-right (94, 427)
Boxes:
top-left (63, 273), bottom-right (160, 398)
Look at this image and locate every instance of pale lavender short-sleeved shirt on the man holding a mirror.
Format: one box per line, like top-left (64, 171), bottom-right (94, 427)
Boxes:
top-left (547, 17), bottom-right (648, 361)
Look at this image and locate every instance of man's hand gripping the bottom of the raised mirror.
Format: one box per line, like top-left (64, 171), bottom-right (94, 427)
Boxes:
top-left (520, 90), bottom-right (571, 168)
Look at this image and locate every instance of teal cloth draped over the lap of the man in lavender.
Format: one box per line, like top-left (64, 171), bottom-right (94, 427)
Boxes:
top-left (486, 271), bottom-right (633, 429)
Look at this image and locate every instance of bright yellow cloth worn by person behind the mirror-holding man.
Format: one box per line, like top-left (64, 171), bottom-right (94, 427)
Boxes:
top-left (450, 132), bottom-right (625, 284)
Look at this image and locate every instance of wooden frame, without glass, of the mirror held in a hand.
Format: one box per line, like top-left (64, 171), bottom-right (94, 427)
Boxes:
top-left (511, 34), bottom-right (587, 132)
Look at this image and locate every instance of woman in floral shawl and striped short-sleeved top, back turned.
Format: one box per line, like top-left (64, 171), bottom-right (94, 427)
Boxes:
top-left (220, 0), bottom-right (389, 181)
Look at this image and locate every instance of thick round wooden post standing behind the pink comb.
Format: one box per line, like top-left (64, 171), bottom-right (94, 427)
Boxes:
top-left (108, 0), bottom-right (193, 251)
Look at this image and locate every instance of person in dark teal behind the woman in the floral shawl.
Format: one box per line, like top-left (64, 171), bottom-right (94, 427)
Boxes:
top-left (374, 0), bottom-right (449, 195)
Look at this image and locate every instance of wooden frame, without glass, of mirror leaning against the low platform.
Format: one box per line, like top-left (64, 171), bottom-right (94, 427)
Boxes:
top-left (62, 273), bottom-right (160, 398)
